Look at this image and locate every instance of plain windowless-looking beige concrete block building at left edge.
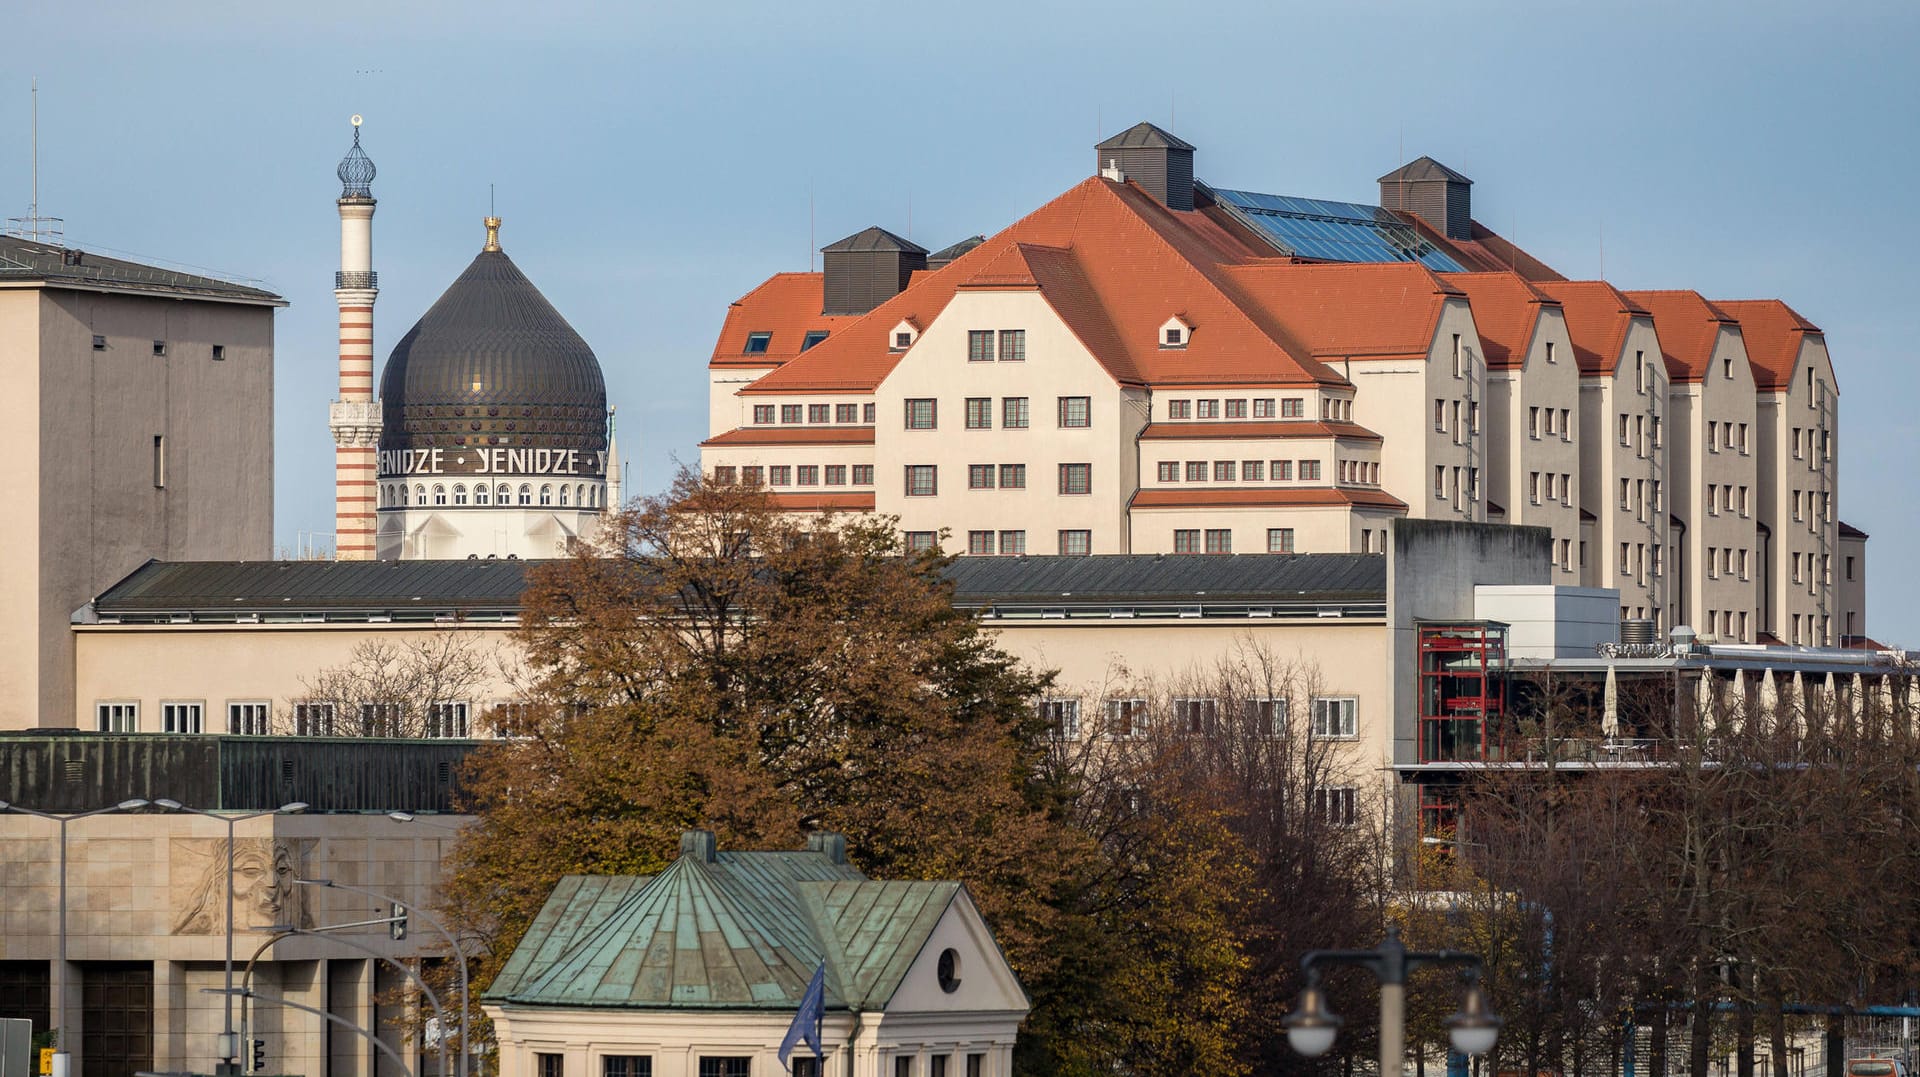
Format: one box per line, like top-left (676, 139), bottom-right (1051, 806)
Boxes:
top-left (0, 236), bottom-right (286, 730)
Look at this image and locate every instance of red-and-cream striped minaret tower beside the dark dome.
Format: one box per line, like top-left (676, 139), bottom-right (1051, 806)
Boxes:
top-left (328, 115), bottom-right (380, 561)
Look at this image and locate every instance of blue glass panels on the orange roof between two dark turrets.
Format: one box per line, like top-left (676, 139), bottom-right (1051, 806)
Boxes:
top-left (1213, 188), bottom-right (1465, 273)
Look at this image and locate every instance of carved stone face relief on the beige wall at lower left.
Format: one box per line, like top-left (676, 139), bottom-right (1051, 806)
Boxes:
top-left (169, 837), bottom-right (313, 935)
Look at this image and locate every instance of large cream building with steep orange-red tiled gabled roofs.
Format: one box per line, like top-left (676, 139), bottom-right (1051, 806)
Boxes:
top-left (703, 125), bottom-right (1864, 645)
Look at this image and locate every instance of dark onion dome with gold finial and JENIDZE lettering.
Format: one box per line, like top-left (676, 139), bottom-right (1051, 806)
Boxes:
top-left (380, 217), bottom-right (607, 476)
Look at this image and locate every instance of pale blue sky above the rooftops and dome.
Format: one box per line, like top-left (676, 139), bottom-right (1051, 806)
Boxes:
top-left (11, 0), bottom-right (1920, 645)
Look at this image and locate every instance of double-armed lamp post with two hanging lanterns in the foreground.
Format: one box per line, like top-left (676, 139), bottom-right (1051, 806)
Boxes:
top-left (1281, 927), bottom-right (1500, 1077)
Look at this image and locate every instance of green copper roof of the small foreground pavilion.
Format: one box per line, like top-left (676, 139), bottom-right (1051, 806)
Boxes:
top-left (486, 837), bottom-right (960, 1010)
